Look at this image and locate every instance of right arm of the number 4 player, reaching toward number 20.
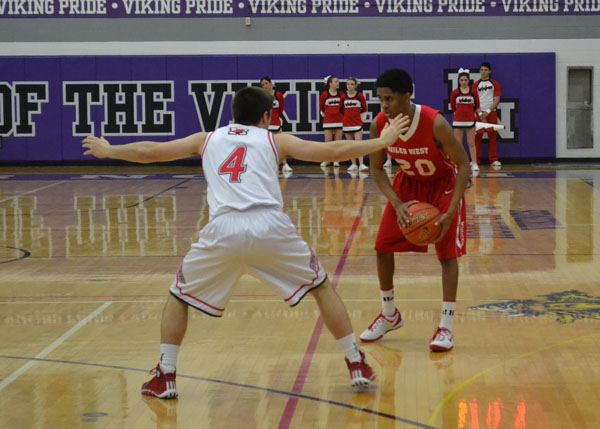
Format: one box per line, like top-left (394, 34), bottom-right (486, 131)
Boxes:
top-left (275, 115), bottom-right (410, 162)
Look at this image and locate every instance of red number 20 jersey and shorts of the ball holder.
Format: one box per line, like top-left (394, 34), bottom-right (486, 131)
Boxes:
top-left (375, 104), bottom-right (467, 260)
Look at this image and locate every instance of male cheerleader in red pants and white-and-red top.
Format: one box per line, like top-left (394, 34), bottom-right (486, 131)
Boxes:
top-left (473, 62), bottom-right (502, 169)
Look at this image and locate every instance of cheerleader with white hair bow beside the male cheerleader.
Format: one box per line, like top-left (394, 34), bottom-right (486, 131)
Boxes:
top-left (450, 68), bottom-right (479, 171)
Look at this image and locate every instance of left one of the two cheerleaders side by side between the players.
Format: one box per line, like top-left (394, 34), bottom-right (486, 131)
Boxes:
top-left (319, 76), bottom-right (345, 167)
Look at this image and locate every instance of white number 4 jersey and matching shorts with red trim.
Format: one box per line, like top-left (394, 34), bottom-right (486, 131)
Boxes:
top-left (170, 124), bottom-right (327, 317)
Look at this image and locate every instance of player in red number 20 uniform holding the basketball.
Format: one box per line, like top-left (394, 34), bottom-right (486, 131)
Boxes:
top-left (360, 69), bottom-right (469, 351)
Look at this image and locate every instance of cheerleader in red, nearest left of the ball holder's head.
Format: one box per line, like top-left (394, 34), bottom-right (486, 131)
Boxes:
top-left (342, 77), bottom-right (369, 171)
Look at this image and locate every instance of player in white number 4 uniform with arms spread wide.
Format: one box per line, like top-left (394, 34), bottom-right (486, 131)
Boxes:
top-left (82, 87), bottom-right (408, 399)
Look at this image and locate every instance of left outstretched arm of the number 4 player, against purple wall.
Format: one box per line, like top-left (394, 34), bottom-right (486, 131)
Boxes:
top-left (81, 133), bottom-right (207, 164)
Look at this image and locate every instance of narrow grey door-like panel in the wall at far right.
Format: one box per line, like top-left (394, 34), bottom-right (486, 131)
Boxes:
top-left (567, 67), bottom-right (594, 149)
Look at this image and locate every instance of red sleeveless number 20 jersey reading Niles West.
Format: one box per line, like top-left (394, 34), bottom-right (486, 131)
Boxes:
top-left (375, 104), bottom-right (456, 182)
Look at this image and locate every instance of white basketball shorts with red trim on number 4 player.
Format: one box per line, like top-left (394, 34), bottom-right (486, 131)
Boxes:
top-left (170, 207), bottom-right (327, 317)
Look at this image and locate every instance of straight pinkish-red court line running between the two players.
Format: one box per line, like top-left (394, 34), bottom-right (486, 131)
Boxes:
top-left (278, 192), bottom-right (369, 429)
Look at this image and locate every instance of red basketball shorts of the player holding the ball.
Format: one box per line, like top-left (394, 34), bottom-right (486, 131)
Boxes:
top-left (375, 172), bottom-right (467, 261)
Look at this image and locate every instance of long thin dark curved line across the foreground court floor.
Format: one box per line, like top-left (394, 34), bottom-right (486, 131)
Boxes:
top-left (0, 355), bottom-right (435, 429)
